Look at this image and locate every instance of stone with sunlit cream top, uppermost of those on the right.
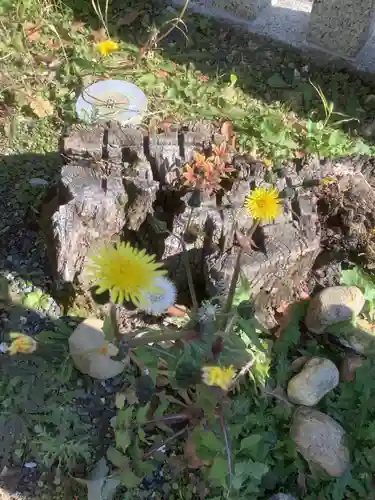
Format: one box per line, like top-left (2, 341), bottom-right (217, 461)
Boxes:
top-left (305, 286), bottom-right (365, 333)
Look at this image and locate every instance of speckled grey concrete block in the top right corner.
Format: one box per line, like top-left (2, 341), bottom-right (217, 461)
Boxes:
top-left (307, 0), bottom-right (375, 57)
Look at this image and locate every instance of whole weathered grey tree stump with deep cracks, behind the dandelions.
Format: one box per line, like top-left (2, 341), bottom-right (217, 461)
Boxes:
top-left (44, 123), bottom-right (328, 322)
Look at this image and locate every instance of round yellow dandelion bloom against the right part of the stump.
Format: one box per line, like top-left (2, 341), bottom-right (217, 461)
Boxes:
top-left (245, 188), bottom-right (282, 222)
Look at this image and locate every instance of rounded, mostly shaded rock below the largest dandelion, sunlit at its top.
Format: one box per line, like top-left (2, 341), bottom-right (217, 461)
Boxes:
top-left (69, 318), bottom-right (129, 380)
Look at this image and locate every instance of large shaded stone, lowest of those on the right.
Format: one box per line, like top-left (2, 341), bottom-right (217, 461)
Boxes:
top-left (290, 407), bottom-right (350, 477)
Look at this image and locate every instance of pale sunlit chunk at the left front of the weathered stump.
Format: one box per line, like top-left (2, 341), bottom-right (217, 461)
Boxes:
top-left (49, 164), bottom-right (128, 282)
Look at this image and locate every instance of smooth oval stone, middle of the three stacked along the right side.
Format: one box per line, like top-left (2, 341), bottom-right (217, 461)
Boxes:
top-left (288, 358), bottom-right (340, 406)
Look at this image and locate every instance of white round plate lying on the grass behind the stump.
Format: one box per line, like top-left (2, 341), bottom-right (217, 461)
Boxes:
top-left (76, 80), bottom-right (147, 124)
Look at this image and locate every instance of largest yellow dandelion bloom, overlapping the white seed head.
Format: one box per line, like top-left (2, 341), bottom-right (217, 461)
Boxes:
top-left (88, 243), bottom-right (166, 306)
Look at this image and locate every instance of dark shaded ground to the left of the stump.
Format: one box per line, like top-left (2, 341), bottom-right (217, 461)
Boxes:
top-left (0, 152), bottom-right (63, 288)
